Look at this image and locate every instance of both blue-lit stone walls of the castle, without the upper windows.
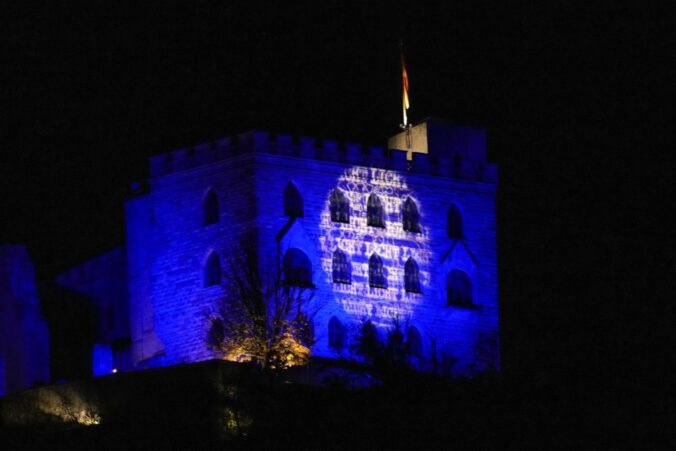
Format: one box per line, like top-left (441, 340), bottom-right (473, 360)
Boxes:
top-left (127, 123), bottom-right (498, 373)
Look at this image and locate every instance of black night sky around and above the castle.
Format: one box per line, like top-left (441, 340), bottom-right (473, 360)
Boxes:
top-left (0, 1), bottom-right (676, 384)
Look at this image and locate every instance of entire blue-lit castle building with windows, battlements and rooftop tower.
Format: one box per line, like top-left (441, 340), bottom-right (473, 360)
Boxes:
top-left (59, 120), bottom-right (499, 374)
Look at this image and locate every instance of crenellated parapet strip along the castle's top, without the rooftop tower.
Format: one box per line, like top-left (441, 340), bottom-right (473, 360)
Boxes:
top-left (150, 127), bottom-right (498, 183)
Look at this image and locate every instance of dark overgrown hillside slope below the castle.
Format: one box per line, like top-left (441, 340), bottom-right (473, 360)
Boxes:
top-left (0, 362), bottom-right (672, 450)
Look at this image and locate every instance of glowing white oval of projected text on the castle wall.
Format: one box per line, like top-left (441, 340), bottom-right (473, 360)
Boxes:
top-left (319, 167), bottom-right (431, 326)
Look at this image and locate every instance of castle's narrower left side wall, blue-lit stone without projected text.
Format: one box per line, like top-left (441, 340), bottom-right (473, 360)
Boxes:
top-left (126, 147), bottom-right (255, 366)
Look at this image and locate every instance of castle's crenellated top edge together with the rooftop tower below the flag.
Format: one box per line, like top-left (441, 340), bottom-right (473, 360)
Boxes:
top-left (149, 120), bottom-right (498, 184)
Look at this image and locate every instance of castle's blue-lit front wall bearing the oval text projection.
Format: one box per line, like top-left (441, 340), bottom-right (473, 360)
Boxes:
top-left (255, 154), bottom-right (498, 372)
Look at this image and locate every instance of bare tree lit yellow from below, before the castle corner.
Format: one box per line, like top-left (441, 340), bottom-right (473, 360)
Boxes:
top-left (207, 237), bottom-right (317, 370)
